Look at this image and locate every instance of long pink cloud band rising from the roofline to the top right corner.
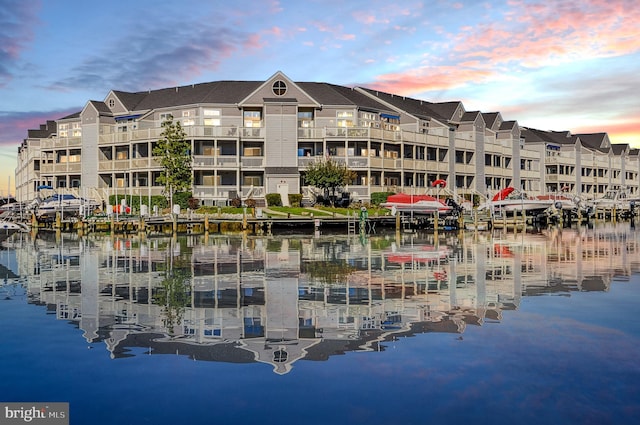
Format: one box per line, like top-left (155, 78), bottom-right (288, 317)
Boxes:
top-left (369, 0), bottom-right (640, 112)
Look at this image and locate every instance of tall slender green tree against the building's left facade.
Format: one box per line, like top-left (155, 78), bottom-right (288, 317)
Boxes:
top-left (153, 117), bottom-right (193, 205)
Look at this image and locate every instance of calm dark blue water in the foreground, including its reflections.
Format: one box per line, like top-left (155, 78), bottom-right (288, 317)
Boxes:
top-left (0, 223), bottom-right (640, 425)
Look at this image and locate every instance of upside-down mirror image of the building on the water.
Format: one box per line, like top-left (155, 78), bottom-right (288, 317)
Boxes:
top-left (9, 226), bottom-right (640, 374)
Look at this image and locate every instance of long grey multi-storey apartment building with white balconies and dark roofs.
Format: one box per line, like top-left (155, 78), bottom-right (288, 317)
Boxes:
top-left (15, 72), bottom-right (639, 205)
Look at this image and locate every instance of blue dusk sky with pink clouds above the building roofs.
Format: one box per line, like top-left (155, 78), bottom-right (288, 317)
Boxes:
top-left (0, 0), bottom-right (640, 194)
